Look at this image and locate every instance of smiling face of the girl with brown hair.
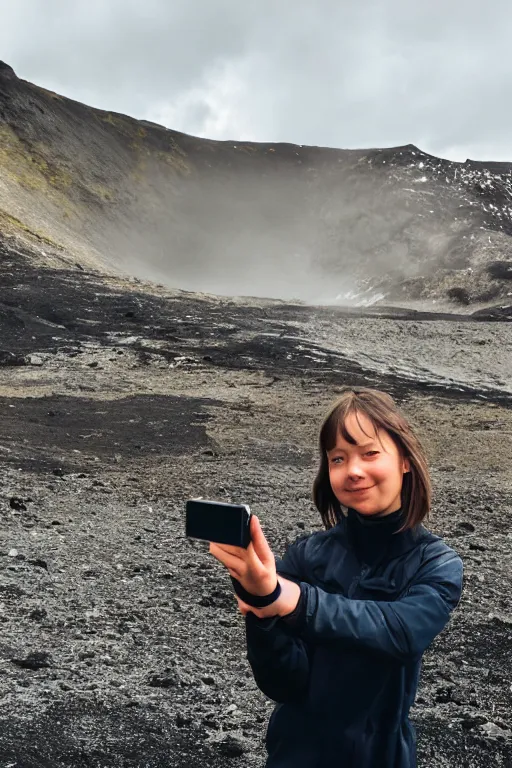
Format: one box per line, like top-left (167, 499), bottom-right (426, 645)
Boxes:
top-left (327, 413), bottom-right (410, 515)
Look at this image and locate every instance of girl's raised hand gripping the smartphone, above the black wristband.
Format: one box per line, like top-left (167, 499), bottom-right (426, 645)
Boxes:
top-left (210, 515), bottom-right (277, 592)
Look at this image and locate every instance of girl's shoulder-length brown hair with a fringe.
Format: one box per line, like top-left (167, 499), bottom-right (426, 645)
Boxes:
top-left (313, 387), bottom-right (432, 531)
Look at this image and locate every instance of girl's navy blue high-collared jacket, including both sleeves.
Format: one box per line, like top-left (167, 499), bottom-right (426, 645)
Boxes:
top-left (246, 510), bottom-right (463, 768)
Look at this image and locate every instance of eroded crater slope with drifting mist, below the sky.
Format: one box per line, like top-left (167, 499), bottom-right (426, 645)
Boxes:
top-left (0, 65), bottom-right (512, 311)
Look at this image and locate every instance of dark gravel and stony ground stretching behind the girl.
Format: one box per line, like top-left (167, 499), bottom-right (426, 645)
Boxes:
top-left (0, 237), bottom-right (512, 768)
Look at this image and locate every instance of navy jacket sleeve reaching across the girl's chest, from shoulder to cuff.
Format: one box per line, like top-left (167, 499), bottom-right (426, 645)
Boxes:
top-left (284, 548), bottom-right (463, 662)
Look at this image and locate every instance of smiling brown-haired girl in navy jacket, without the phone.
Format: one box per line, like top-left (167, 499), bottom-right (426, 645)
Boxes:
top-left (210, 388), bottom-right (463, 768)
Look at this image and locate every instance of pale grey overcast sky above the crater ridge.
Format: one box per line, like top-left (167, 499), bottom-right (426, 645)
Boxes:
top-left (0, 0), bottom-right (512, 160)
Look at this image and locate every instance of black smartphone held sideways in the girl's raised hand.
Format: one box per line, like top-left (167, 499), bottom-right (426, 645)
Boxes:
top-left (185, 499), bottom-right (251, 549)
